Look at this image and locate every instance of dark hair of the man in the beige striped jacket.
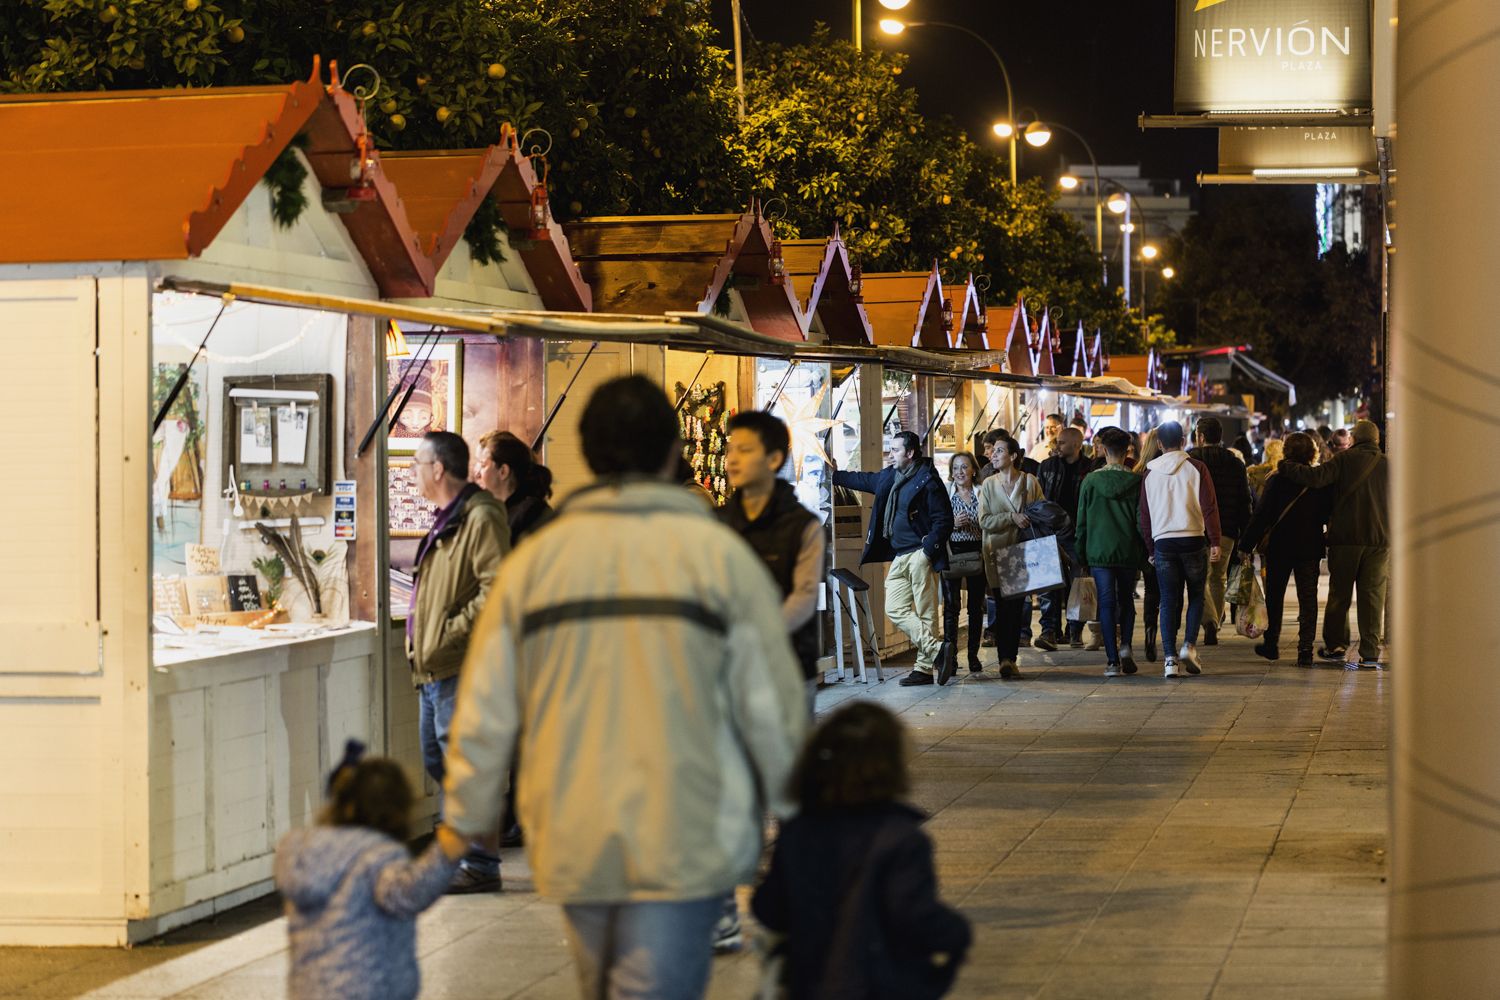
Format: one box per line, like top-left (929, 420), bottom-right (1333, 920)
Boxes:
top-left (578, 375), bottom-right (678, 477)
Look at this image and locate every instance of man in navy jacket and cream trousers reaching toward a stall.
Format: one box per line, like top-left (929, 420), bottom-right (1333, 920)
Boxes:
top-left (834, 430), bottom-right (957, 687)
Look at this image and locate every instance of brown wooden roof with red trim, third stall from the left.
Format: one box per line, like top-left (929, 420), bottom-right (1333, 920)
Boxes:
top-left (566, 205), bottom-right (804, 340)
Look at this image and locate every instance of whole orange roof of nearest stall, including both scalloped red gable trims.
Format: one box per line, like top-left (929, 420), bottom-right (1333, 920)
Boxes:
top-left (0, 58), bottom-right (437, 297)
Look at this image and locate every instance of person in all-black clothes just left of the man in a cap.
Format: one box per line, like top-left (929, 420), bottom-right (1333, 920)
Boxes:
top-left (1241, 433), bottom-right (1334, 667)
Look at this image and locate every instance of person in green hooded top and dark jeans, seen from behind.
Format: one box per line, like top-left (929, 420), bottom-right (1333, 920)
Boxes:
top-left (1074, 427), bottom-right (1146, 678)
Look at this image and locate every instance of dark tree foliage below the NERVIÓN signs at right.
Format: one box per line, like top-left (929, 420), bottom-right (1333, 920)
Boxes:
top-left (1160, 187), bottom-right (1380, 406)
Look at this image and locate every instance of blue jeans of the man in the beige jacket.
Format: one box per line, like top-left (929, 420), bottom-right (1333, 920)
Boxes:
top-left (563, 897), bottom-right (723, 1000)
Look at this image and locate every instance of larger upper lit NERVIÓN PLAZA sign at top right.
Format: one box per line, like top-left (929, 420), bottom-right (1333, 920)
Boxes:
top-left (1175, 0), bottom-right (1373, 114)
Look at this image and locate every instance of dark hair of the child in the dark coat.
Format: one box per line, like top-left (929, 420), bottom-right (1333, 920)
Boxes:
top-left (789, 702), bottom-right (911, 813)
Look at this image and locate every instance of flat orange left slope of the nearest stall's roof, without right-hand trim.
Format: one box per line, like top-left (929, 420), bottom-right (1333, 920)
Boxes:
top-left (0, 60), bottom-right (324, 264)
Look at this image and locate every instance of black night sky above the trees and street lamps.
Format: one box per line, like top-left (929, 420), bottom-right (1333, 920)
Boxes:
top-left (714, 0), bottom-right (1217, 185)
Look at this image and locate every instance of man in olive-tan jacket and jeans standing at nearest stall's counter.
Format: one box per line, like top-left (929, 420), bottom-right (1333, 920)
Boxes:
top-left (407, 430), bottom-right (510, 892)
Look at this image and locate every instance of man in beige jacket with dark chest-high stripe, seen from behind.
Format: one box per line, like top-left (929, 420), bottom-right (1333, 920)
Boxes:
top-left (446, 376), bottom-right (807, 1000)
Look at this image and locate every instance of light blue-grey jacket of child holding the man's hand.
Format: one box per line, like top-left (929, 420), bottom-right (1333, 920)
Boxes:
top-left (275, 826), bottom-right (458, 1000)
